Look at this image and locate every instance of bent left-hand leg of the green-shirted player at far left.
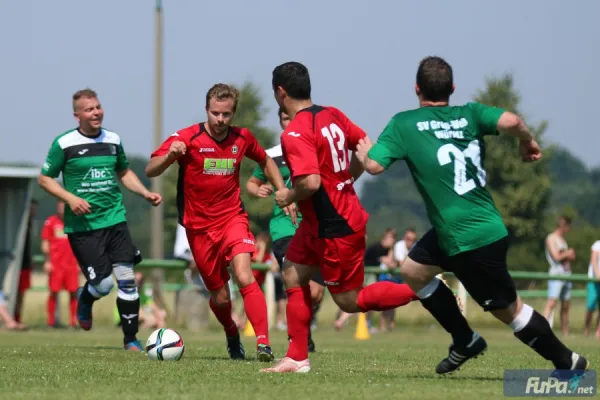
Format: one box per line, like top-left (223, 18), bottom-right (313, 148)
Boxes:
top-left (68, 229), bottom-right (114, 331)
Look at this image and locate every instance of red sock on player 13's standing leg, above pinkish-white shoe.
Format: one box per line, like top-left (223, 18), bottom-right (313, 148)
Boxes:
top-left (285, 285), bottom-right (312, 361)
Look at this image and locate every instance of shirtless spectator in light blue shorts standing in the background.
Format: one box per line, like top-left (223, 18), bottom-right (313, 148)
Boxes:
top-left (544, 215), bottom-right (575, 336)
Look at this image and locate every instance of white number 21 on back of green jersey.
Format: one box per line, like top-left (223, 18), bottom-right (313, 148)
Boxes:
top-left (437, 140), bottom-right (486, 196)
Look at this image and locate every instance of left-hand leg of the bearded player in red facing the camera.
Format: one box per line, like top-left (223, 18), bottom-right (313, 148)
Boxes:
top-left (186, 229), bottom-right (245, 360)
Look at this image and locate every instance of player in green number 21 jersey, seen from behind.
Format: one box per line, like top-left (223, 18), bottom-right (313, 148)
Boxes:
top-left (358, 57), bottom-right (589, 374)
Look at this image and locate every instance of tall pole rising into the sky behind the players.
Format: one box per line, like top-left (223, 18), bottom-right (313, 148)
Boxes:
top-left (151, 0), bottom-right (166, 307)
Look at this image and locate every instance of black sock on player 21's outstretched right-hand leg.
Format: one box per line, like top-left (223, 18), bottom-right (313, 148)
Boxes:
top-left (515, 310), bottom-right (573, 369)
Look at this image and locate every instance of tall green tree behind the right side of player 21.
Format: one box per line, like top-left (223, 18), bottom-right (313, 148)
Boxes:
top-left (474, 74), bottom-right (551, 270)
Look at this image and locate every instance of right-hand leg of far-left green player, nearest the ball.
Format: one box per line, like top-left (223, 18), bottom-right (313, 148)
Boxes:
top-left (106, 222), bottom-right (144, 351)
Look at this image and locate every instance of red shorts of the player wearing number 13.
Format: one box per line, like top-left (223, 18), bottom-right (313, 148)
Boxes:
top-left (285, 223), bottom-right (367, 293)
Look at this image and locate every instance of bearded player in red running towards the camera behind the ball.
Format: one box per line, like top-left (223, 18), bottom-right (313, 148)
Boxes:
top-left (146, 84), bottom-right (295, 361)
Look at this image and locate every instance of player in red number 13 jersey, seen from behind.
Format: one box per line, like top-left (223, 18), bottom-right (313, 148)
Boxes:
top-left (263, 62), bottom-right (417, 372)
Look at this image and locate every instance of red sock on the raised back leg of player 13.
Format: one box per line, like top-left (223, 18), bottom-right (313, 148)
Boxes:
top-left (357, 281), bottom-right (419, 312)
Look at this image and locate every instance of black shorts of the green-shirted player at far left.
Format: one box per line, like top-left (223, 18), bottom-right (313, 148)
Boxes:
top-left (68, 222), bottom-right (136, 285)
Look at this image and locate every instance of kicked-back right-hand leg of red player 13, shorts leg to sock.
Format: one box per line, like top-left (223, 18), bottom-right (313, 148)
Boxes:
top-left (326, 231), bottom-right (418, 313)
